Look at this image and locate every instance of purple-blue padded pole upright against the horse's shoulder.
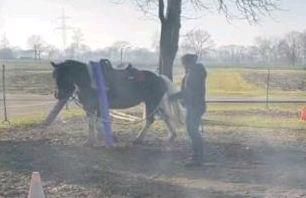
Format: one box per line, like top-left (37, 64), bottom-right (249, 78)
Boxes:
top-left (90, 61), bottom-right (114, 147)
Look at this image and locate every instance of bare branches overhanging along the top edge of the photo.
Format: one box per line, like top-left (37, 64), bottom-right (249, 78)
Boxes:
top-left (116, 0), bottom-right (280, 23)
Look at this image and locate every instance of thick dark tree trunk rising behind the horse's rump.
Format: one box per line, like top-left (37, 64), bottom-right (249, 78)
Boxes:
top-left (159, 0), bottom-right (182, 80)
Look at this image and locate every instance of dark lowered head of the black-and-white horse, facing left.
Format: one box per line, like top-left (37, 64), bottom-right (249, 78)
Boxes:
top-left (51, 61), bottom-right (75, 100)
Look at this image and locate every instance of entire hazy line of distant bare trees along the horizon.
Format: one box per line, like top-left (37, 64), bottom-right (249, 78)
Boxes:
top-left (0, 29), bottom-right (306, 67)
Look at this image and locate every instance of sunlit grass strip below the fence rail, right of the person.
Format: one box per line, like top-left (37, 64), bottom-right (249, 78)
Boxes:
top-left (208, 104), bottom-right (306, 131)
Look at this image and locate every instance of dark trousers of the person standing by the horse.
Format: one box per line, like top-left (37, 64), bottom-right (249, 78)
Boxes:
top-left (186, 107), bottom-right (204, 161)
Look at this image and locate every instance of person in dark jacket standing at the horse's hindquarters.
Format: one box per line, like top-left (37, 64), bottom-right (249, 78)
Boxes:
top-left (170, 54), bottom-right (207, 166)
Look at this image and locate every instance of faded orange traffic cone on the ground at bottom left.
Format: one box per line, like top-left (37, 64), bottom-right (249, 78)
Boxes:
top-left (28, 172), bottom-right (45, 198)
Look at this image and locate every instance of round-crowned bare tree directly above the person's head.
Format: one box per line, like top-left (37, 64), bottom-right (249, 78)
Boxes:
top-left (182, 29), bottom-right (214, 58)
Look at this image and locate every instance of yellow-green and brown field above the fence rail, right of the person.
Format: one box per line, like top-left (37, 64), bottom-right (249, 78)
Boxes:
top-left (207, 69), bottom-right (306, 98)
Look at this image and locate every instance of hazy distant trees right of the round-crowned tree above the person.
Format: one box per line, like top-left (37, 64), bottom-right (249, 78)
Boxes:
top-left (204, 31), bottom-right (306, 66)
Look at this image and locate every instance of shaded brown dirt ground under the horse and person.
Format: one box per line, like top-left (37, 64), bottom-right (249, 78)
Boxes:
top-left (0, 115), bottom-right (306, 198)
